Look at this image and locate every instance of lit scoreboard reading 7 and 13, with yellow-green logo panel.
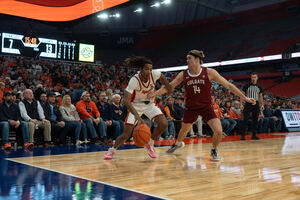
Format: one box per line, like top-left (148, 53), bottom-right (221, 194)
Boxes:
top-left (0, 33), bottom-right (94, 62)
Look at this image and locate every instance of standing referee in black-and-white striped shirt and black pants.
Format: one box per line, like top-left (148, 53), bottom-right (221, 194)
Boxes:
top-left (241, 72), bottom-right (264, 140)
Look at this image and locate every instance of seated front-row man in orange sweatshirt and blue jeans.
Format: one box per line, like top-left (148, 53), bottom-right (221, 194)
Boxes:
top-left (76, 91), bottom-right (106, 144)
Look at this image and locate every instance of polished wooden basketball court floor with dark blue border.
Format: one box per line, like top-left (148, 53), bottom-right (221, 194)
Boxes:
top-left (1, 132), bottom-right (300, 199)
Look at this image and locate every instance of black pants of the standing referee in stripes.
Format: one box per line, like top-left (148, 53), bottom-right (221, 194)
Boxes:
top-left (241, 101), bottom-right (260, 137)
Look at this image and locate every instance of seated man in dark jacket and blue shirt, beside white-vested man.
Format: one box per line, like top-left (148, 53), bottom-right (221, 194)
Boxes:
top-left (43, 92), bottom-right (81, 144)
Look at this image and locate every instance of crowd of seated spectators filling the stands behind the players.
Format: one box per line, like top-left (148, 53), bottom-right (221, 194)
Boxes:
top-left (0, 55), bottom-right (300, 149)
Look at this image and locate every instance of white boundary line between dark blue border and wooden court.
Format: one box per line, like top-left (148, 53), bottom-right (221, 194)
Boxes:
top-left (6, 158), bottom-right (169, 200)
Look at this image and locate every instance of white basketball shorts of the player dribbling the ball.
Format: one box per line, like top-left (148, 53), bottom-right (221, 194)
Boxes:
top-left (125, 102), bottom-right (163, 125)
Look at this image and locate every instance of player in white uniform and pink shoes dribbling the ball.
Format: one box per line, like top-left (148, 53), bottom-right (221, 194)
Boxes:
top-left (104, 56), bottom-right (172, 160)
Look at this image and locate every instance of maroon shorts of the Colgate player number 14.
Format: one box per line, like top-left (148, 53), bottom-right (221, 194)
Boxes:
top-left (183, 105), bottom-right (218, 124)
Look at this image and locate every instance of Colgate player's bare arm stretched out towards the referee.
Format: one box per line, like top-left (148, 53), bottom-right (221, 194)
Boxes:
top-left (207, 68), bottom-right (256, 105)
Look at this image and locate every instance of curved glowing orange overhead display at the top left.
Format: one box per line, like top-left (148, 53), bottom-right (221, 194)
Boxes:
top-left (0, 0), bottom-right (129, 21)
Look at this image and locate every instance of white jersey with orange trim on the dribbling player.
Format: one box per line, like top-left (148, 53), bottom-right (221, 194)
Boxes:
top-left (126, 70), bottom-right (161, 104)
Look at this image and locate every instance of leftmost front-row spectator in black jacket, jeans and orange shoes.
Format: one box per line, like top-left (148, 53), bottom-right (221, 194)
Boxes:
top-left (0, 92), bottom-right (33, 149)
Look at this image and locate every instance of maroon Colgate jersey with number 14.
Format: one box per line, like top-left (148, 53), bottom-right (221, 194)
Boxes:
top-left (183, 67), bottom-right (212, 110)
